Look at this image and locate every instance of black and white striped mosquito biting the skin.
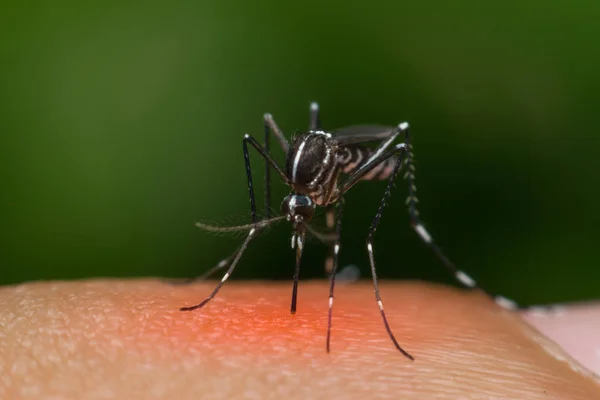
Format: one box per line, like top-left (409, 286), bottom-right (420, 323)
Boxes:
top-left (181, 103), bottom-right (516, 360)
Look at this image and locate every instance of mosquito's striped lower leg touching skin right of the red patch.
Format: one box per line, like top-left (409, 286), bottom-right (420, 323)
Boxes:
top-left (367, 146), bottom-right (414, 360)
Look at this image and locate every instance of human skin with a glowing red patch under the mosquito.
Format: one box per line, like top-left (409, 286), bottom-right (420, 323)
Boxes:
top-left (0, 279), bottom-right (600, 400)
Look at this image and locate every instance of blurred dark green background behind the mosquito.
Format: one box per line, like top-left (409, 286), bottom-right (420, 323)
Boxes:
top-left (0, 0), bottom-right (600, 304)
